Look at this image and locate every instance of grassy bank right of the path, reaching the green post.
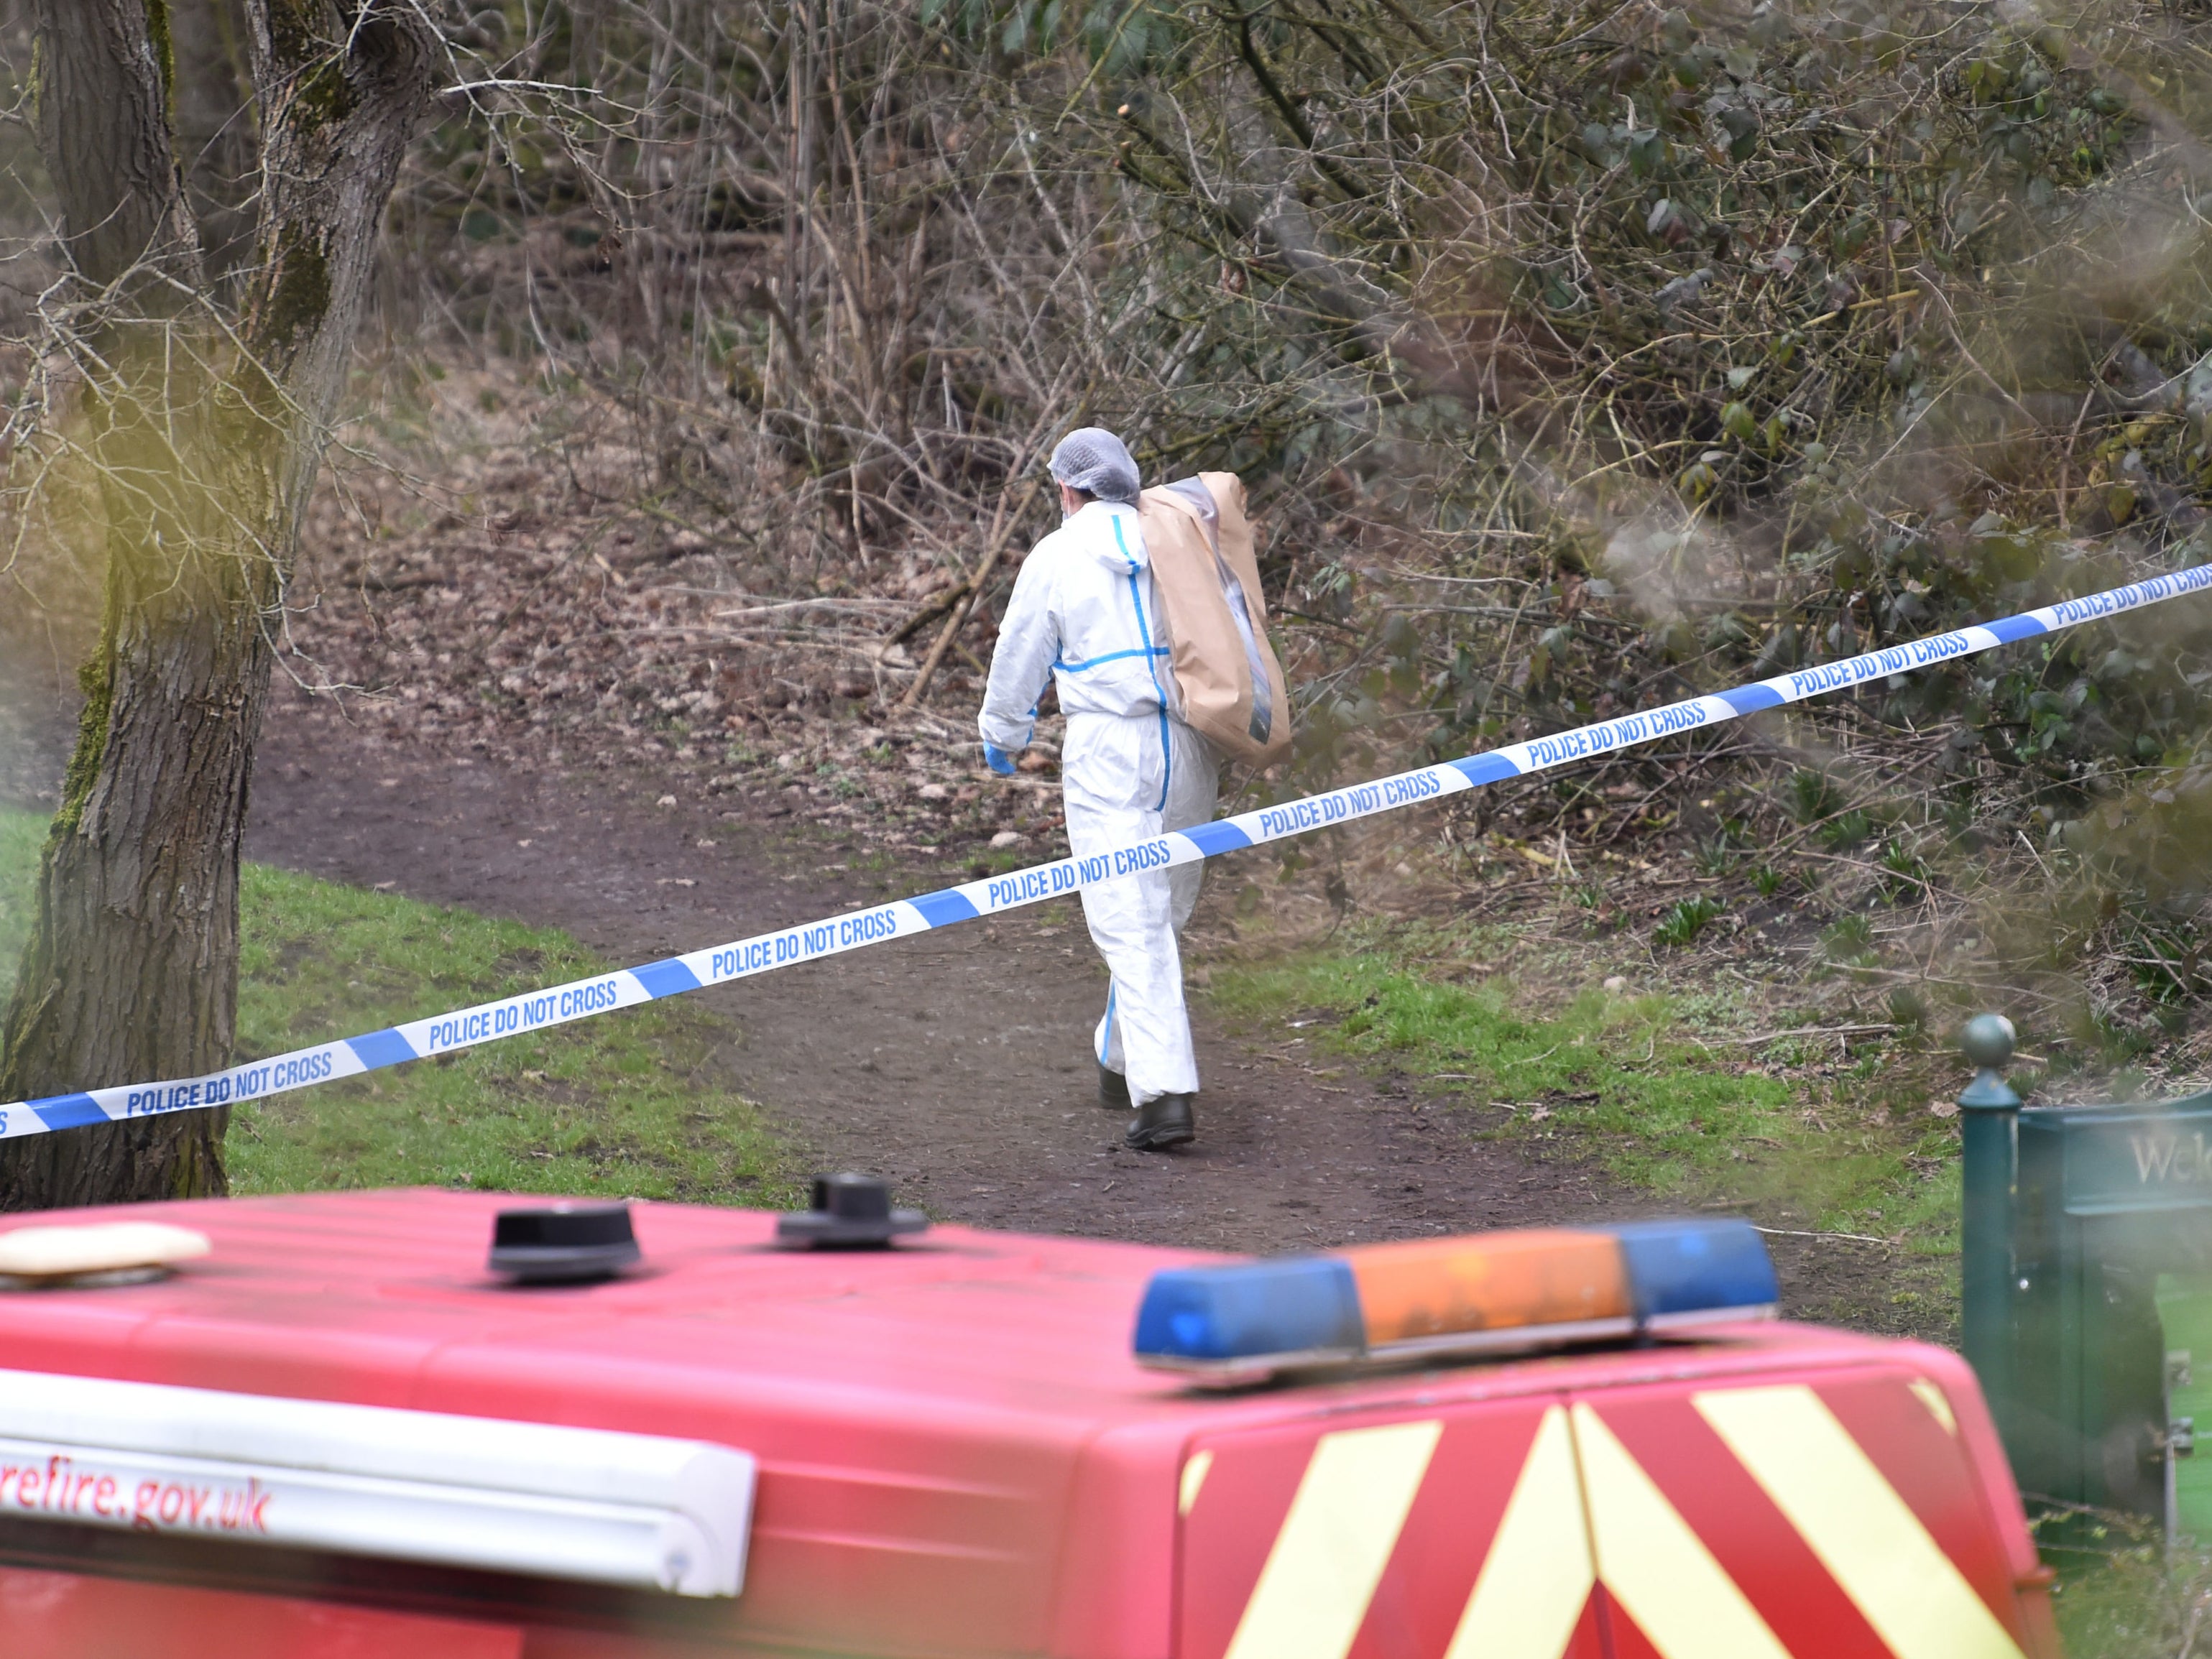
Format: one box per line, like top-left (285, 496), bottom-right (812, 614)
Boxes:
top-left (1208, 920), bottom-right (1958, 1323)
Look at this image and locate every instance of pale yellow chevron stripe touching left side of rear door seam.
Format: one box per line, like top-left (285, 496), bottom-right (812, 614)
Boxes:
top-left (1444, 1407), bottom-right (1597, 1659)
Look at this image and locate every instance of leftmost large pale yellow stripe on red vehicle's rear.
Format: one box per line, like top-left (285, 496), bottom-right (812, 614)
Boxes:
top-left (1225, 1423), bottom-right (1444, 1659)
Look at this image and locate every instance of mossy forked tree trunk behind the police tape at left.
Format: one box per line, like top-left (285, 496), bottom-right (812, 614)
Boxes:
top-left (0, 0), bottom-right (436, 1210)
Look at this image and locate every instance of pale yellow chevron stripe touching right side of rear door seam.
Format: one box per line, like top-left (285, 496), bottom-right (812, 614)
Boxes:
top-left (1575, 1405), bottom-right (1789, 1659)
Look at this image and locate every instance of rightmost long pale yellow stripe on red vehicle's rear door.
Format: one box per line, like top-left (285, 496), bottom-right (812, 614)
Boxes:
top-left (1690, 1385), bottom-right (2019, 1659)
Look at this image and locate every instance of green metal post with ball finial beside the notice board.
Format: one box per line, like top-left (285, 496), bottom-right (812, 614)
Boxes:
top-left (1958, 1013), bottom-right (2019, 1431)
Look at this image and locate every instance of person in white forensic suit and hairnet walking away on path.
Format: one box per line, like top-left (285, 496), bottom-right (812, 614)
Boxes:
top-left (977, 427), bottom-right (1221, 1150)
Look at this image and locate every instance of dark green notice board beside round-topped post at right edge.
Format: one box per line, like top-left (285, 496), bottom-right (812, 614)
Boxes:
top-left (2008, 1093), bottom-right (2212, 1542)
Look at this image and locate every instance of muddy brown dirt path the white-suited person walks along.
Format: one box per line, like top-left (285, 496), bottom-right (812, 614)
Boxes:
top-left (248, 708), bottom-right (1637, 1249)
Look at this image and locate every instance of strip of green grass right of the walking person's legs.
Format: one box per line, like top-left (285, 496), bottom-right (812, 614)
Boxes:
top-left (1212, 929), bottom-right (1955, 1254)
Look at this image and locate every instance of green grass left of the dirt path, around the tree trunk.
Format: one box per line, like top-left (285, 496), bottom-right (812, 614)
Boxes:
top-left (0, 814), bottom-right (798, 1206)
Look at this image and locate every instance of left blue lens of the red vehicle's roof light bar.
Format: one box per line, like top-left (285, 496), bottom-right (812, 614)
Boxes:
top-left (1137, 1257), bottom-right (1367, 1369)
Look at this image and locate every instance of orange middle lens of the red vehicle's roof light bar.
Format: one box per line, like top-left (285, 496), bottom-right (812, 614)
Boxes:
top-left (1338, 1228), bottom-right (1635, 1347)
